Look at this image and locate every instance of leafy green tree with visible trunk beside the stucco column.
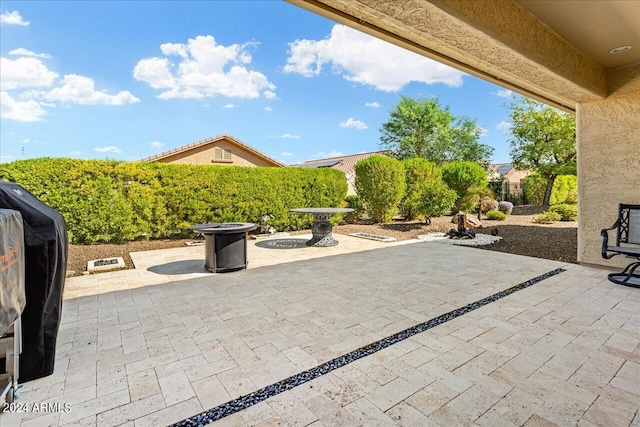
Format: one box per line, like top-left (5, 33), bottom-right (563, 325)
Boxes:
top-left (509, 97), bottom-right (576, 205)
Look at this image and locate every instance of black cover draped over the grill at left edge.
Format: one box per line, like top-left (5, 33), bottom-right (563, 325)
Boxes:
top-left (0, 181), bottom-right (68, 381)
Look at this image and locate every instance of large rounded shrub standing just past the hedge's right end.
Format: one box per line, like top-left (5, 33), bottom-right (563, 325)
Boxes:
top-left (355, 156), bottom-right (406, 222)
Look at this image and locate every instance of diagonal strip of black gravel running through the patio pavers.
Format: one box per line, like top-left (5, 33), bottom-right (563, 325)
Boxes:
top-left (172, 268), bottom-right (566, 427)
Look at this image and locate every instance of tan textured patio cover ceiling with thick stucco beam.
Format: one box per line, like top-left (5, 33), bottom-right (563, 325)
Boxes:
top-left (287, 0), bottom-right (640, 112)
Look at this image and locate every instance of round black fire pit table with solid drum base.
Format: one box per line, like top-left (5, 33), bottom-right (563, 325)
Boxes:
top-left (189, 222), bottom-right (258, 273)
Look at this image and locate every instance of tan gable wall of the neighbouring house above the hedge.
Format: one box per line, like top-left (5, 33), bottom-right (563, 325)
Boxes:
top-left (158, 141), bottom-right (275, 166)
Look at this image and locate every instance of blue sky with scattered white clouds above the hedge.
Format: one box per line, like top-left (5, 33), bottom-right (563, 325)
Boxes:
top-left (0, 0), bottom-right (511, 164)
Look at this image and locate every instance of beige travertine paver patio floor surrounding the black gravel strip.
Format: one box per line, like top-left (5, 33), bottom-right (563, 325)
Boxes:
top-left (0, 237), bottom-right (640, 427)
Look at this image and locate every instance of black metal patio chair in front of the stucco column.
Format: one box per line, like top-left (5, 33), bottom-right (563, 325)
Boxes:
top-left (600, 203), bottom-right (640, 288)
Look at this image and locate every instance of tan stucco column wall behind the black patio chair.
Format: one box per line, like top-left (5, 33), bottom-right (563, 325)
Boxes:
top-left (576, 65), bottom-right (640, 267)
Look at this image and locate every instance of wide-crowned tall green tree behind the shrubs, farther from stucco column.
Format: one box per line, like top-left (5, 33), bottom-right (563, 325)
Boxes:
top-left (380, 95), bottom-right (493, 168)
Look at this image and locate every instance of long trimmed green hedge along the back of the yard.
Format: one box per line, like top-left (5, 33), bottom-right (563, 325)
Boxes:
top-left (0, 158), bottom-right (347, 243)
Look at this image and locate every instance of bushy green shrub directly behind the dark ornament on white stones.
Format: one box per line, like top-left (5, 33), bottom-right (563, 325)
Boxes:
top-left (442, 162), bottom-right (493, 212)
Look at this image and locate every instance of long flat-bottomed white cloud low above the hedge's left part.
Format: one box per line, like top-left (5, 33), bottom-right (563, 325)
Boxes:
top-left (37, 74), bottom-right (140, 105)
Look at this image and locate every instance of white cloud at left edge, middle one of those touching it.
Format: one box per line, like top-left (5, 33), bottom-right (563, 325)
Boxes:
top-left (0, 58), bottom-right (58, 90)
